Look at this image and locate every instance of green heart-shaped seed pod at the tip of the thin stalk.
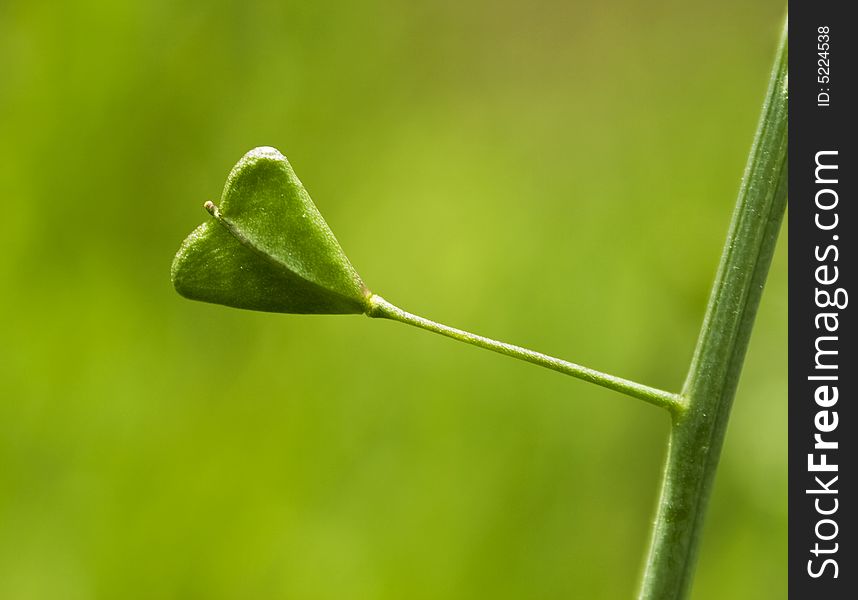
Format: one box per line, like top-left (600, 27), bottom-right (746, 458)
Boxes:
top-left (172, 147), bottom-right (370, 313)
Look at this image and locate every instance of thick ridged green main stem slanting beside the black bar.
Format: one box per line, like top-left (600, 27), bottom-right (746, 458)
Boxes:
top-left (639, 21), bottom-right (788, 600)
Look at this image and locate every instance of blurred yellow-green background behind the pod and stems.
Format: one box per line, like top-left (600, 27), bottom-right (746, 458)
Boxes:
top-left (0, 0), bottom-right (787, 600)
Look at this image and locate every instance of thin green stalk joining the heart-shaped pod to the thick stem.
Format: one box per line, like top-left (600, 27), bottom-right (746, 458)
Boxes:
top-left (367, 295), bottom-right (683, 414)
